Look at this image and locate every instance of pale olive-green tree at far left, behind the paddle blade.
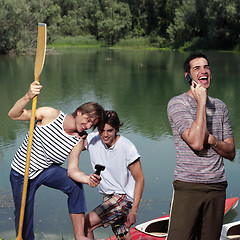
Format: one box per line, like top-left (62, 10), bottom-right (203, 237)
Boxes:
top-left (0, 0), bottom-right (57, 54)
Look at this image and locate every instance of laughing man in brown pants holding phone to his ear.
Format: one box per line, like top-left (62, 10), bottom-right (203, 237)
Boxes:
top-left (167, 53), bottom-right (235, 240)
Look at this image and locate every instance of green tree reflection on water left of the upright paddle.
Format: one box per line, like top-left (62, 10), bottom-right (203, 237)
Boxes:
top-left (0, 56), bottom-right (34, 147)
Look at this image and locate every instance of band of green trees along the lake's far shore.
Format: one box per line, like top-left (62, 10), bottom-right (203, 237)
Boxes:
top-left (0, 0), bottom-right (240, 54)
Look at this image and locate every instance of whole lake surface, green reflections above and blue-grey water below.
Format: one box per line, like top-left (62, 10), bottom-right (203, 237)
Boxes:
top-left (0, 49), bottom-right (240, 239)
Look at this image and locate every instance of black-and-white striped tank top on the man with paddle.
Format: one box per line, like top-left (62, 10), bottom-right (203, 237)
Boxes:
top-left (11, 112), bottom-right (81, 179)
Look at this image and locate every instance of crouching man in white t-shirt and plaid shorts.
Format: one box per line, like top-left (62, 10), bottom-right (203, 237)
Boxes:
top-left (69, 111), bottom-right (144, 239)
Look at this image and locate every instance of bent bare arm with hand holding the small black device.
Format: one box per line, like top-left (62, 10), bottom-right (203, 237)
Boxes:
top-left (68, 141), bottom-right (99, 187)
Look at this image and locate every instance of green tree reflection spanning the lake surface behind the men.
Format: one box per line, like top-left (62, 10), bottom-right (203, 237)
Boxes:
top-left (0, 49), bottom-right (240, 146)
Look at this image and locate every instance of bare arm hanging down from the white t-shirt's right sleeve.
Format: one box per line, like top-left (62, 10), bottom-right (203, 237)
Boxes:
top-left (125, 159), bottom-right (144, 228)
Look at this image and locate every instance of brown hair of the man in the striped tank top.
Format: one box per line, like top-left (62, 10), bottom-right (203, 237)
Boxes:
top-left (72, 102), bottom-right (105, 129)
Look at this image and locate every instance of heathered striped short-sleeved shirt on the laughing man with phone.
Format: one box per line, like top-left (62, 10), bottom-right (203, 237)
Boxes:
top-left (168, 93), bottom-right (233, 183)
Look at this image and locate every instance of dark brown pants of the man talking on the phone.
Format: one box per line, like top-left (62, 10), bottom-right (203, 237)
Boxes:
top-left (166, 180), bottom-right (227, 240)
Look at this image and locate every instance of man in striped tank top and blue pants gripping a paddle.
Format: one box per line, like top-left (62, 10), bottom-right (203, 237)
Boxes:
top-left (8, 81), bottom-right (105, 240)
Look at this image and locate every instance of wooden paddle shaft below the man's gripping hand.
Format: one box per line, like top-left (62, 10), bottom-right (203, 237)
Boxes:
top-left (16, 92), bottom-right (39, 240)
